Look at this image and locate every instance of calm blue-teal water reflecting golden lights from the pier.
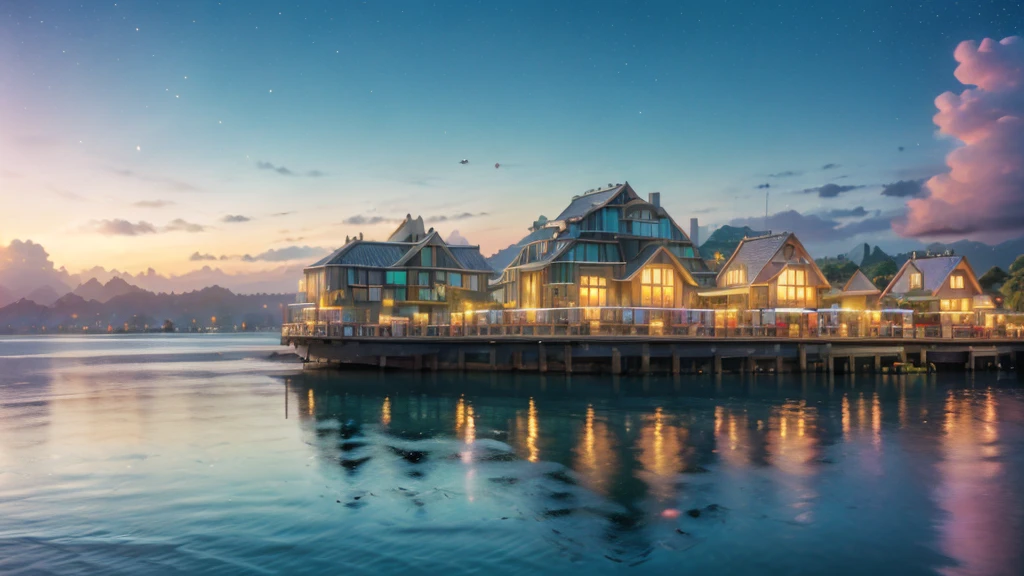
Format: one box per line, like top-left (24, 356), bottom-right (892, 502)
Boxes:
top-left (0, 335), bottom-right (1024, 574)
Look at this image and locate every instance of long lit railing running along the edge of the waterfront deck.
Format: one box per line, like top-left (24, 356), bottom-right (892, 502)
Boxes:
top-left (282, 307), bottom-right (1024, 340)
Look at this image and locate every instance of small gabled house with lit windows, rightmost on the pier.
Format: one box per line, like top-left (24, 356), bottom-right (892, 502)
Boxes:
top-left (881, 253), bottom-right (982, 312)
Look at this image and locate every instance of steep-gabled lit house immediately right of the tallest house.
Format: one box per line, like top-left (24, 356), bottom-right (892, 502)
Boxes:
top-left (700, 233), bottom-right (829, 310)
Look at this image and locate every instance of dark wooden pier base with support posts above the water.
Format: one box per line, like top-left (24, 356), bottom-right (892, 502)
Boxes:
top-left (282, 335), bottom-right (1024, 374)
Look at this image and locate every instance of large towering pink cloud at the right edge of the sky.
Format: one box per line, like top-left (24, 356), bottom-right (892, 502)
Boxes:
top-left (895, 36), bottom-right (1024, 242)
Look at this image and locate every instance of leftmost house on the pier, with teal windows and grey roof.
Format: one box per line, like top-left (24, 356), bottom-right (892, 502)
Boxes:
top-left (300, 215), bottom-right (492, 324)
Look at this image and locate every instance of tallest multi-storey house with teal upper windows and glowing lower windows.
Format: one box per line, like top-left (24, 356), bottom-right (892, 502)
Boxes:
top-left (492, 182), bottom-right (714, 310)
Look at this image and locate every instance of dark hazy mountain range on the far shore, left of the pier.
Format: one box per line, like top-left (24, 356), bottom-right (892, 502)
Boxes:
top-left (0, 282), bottom-right (295, 333)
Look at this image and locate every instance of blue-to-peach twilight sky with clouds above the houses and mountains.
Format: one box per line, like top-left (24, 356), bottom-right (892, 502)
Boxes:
top-left (0, 0), bottom-right (1024, 286)
